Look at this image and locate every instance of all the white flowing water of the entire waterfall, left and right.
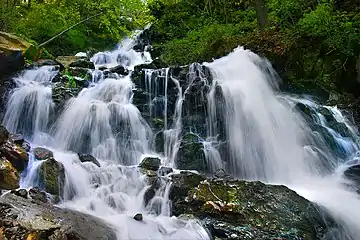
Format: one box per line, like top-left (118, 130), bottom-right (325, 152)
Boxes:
top-left (4, 39), bottom-right (360, 240)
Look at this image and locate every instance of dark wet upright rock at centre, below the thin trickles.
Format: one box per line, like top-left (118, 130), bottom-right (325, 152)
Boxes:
top-left (176, 133), bottom-right (206, 172)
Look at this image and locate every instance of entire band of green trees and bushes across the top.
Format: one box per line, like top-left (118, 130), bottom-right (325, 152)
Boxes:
top-left (0, 0), bottom-right (360, 96)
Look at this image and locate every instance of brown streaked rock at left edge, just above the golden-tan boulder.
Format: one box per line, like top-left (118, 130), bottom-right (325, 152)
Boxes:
top-left (0, 140), bottom-right (29, 172)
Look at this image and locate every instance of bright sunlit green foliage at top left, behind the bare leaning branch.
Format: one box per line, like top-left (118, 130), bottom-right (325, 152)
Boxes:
top-left (0, 0), bottom-right (150, 55)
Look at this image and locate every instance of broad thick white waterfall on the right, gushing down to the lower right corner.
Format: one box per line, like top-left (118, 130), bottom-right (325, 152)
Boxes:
top-left (205, 47), bottom-right (360, 240)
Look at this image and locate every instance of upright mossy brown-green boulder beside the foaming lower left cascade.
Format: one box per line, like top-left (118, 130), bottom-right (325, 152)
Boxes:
top-left (39, 158), bottom-right (65, 196)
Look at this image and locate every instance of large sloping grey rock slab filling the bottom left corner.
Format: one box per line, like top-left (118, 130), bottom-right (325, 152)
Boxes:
top-left (0, 194), bottom-right (117, 240)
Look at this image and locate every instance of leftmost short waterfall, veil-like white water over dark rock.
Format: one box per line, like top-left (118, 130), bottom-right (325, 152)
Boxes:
top-left (4, 66), bottom-right (57, 141)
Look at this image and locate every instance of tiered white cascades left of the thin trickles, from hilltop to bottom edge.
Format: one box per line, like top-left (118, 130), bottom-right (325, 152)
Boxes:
top-left (4, 37), bottom-right (209, 239)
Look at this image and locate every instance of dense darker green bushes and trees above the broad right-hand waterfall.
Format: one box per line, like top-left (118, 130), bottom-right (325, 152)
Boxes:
top-left (149, 0), bottom-right (360, 96)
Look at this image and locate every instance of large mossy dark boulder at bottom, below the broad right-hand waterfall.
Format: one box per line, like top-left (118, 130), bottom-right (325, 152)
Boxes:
top-left (174, 180), bottom-right (326, 240)
